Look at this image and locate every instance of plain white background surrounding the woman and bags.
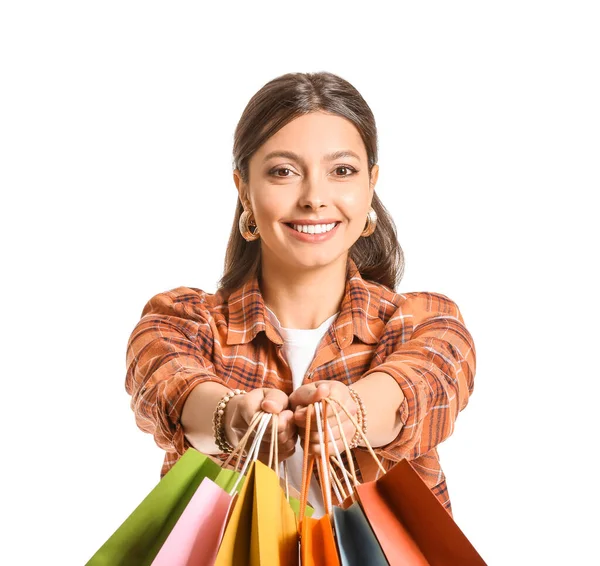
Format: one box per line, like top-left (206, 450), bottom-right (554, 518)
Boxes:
top-left (0, 0), bottom-right (600, 565)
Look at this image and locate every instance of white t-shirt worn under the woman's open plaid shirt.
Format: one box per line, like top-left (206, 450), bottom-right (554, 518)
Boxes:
top-left (265, 305), bottom-right (339, 518)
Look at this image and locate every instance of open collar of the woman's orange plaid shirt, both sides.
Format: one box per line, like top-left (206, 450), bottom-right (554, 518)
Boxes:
top-left (227, 256), bottom-right (384, 349)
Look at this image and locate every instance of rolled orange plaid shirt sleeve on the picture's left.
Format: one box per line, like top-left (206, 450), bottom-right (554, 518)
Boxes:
top-left (125, 287), bottom-right (226, 455)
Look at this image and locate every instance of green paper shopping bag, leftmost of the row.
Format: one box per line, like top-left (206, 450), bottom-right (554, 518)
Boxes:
top-left (86, 448), bottom-right (239, 566)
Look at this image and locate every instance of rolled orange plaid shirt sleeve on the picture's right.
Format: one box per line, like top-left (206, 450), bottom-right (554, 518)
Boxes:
top-left (363, 292), bottom-right (476, 462)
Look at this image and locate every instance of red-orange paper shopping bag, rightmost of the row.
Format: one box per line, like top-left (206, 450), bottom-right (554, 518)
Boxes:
top-left (356, 460), bottom-right (485, 566)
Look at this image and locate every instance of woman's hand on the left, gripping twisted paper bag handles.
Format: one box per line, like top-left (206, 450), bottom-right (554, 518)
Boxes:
top-left (224, 387), bottom-right (298, 463)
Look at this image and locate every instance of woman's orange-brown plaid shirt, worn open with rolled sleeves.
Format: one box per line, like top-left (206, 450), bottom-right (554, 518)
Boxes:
top-left (125, 257), bottom-right (475, 515)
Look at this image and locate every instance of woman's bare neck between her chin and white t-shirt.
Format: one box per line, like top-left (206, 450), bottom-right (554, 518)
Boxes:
top-left (260, 254), bottom-right (347, 329)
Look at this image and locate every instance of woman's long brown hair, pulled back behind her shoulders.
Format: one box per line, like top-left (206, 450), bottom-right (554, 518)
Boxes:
top-left (219, 72), bottom-right (404, 294)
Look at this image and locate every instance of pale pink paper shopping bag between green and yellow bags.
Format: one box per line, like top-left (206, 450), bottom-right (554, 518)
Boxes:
top-left (152, 478), bottom-right (233, 566)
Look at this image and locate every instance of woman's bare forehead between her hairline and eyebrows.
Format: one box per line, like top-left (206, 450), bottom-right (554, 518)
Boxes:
top-left (256, 112), bottom-right (367, 161)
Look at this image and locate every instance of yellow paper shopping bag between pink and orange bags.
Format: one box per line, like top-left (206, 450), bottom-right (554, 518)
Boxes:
top-left (215, 461), bottom-right (298, 566)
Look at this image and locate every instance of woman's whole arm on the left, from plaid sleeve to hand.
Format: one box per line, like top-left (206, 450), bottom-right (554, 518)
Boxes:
top-left (125, 287), bottom-right (297, 460)
